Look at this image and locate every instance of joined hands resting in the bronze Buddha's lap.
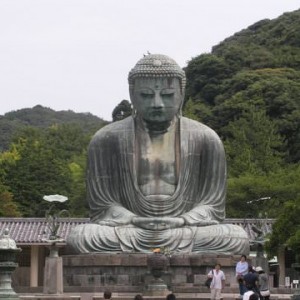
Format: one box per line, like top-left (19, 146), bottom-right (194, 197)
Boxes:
top-left (132, 217), bottom-right (184, 230)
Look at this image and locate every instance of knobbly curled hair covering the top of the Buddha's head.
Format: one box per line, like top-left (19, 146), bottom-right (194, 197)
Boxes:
top-left (128, 54), bottom-right (186, 91)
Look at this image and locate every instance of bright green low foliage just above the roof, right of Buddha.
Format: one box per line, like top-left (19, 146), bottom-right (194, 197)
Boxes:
top-left (226, 165), bottom-right (300, 218)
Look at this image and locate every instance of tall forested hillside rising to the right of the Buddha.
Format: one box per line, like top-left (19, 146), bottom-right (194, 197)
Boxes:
top-left (184, 10), bottom-right (300, 253)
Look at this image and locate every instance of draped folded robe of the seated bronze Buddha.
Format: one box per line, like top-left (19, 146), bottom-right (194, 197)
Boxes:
top-left (67, 117), bottom-right (249, 254)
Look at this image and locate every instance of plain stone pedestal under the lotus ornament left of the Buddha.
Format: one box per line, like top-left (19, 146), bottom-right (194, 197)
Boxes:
top-left (43, 257), bottom-right (63, 294)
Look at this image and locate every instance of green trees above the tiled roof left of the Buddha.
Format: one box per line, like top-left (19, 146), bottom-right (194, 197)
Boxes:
top-left (3, 124), bottom-right (90, 217)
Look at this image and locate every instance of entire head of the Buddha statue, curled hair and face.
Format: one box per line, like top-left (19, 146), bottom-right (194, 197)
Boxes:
top-left (128, 54), bottom-right (185, 124)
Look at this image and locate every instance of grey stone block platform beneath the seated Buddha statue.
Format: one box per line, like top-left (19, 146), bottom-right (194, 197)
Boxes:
top-left (63, 253), bottom-right (240, 293)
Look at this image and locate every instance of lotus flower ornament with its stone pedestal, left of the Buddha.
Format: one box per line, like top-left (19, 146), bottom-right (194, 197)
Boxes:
top-left (43, 195), bottom-right (68, 294)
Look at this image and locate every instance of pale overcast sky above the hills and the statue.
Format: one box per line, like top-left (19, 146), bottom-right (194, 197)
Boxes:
top-left (0, 0), bottom-right (300, 120)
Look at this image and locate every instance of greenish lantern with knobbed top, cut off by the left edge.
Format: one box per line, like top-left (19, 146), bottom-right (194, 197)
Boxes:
top-left (0, 229), bottom-right (21, 300)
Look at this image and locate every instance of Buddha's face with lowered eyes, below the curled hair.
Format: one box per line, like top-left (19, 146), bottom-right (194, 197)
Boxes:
top-left (131, 78), bottom-right (183, 123)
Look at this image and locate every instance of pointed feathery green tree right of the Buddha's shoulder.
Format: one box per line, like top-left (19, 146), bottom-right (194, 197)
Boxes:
top-left (222, 107), bottom-right (283, 177)
